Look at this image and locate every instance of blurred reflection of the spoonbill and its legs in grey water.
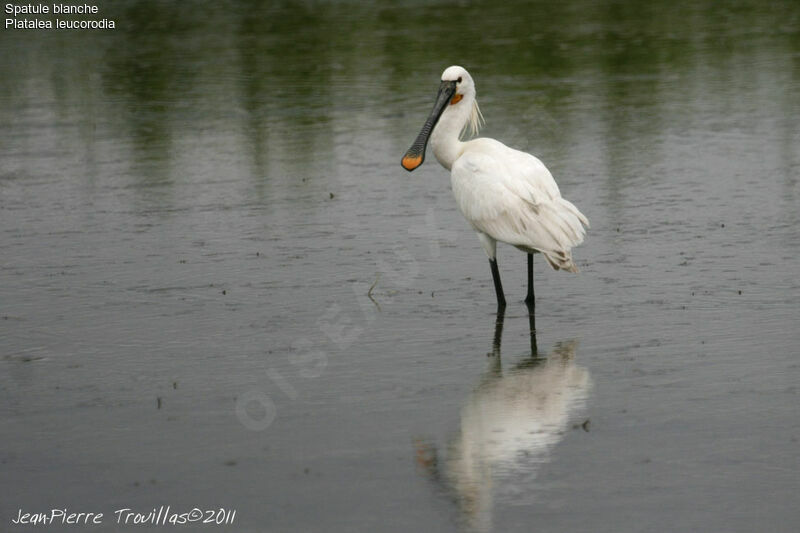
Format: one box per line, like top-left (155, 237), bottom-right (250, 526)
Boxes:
top-left (415, 307), bottom-right (591, 531)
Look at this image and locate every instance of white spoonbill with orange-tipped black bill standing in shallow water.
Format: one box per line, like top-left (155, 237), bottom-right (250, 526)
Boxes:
top-left (402, 65), bottom-right (589, 308)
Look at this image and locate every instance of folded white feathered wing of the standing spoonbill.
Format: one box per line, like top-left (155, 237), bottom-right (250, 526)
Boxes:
top-left (451, 145), bottom-right (588, 270)
